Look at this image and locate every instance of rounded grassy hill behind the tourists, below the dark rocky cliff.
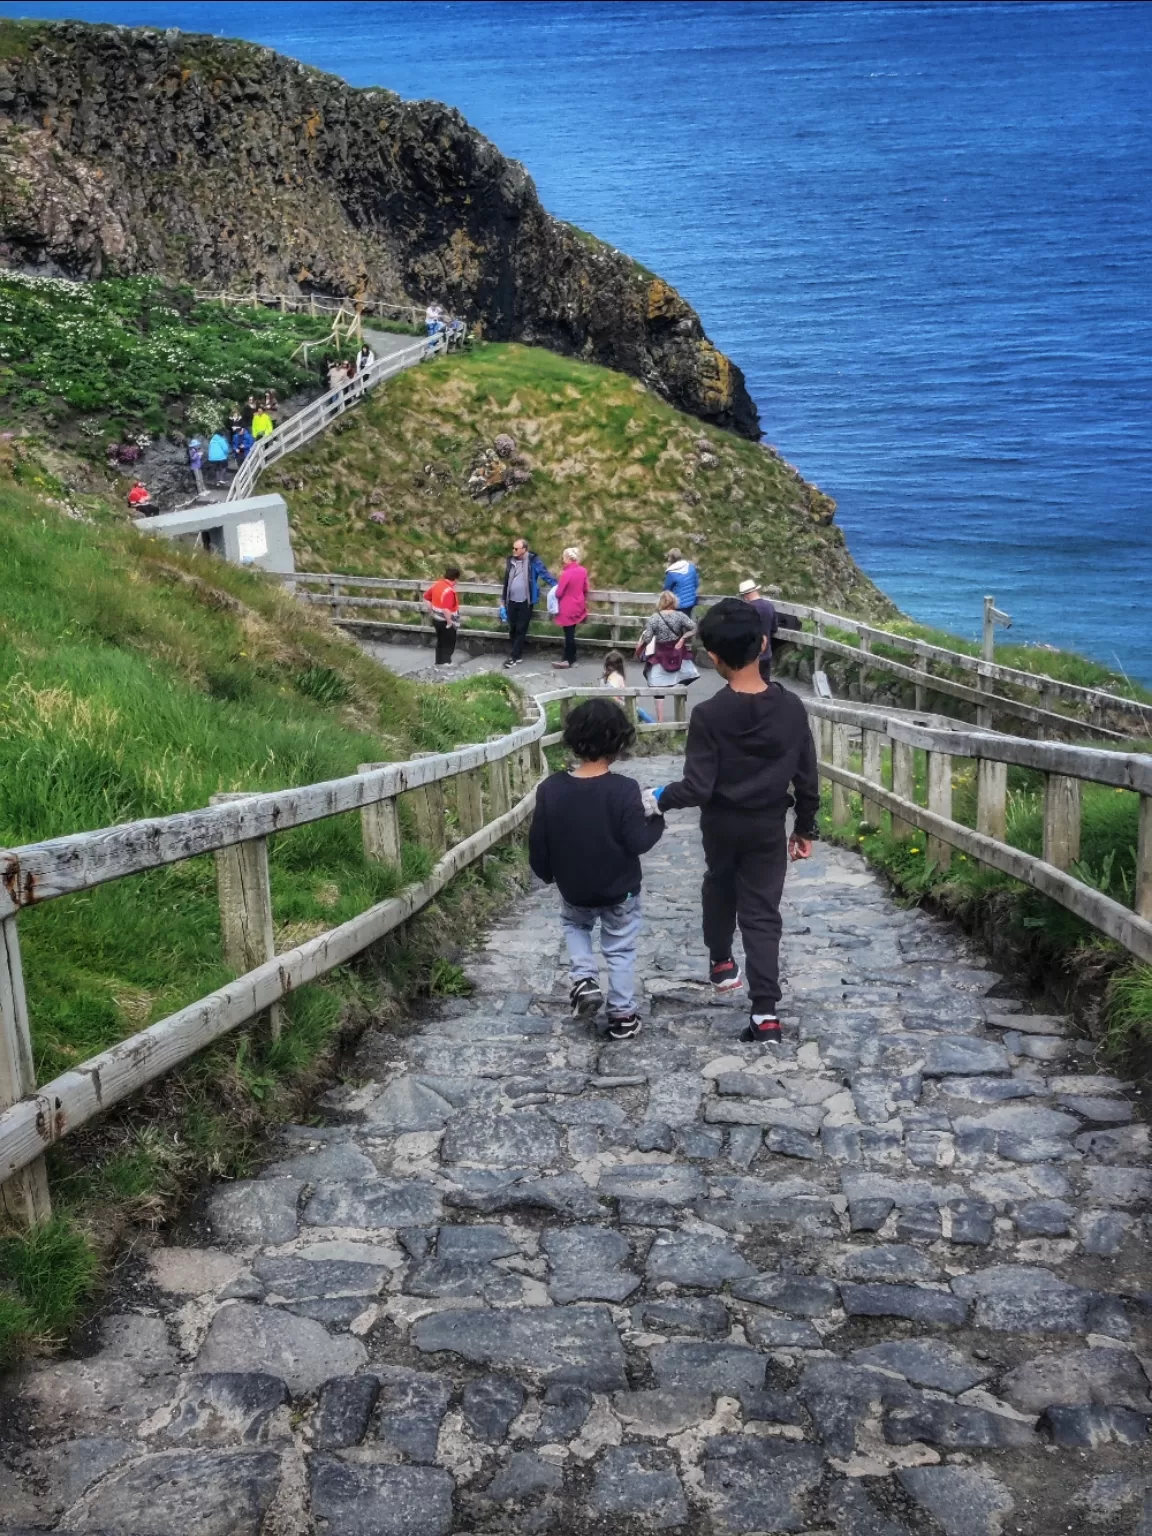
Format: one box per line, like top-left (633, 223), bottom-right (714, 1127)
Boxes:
top-left (261, 344), bottom-right (895, 616)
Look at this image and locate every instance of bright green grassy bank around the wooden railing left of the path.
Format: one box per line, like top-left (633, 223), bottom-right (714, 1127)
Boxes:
top-left (0, 481), bottom-right (516, 1355)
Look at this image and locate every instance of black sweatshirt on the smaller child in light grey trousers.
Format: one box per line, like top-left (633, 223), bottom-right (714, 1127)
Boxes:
top-left (528, 773), bottom-right (664, 906)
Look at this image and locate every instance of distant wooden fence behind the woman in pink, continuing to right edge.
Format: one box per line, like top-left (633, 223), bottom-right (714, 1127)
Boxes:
top-left (284, 571), bottom-right (1152, 742)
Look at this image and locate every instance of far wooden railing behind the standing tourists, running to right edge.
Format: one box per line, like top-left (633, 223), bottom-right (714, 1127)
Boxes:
top-left (284, 571), bottom-right (1152, 742)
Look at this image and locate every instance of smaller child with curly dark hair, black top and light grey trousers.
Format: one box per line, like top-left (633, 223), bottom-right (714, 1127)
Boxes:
top-left (528, 699), bottom-right (664, 1040)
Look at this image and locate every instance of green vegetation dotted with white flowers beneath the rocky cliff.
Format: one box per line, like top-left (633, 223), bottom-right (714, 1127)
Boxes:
top-left (0, 272), bottom-right (329, 447)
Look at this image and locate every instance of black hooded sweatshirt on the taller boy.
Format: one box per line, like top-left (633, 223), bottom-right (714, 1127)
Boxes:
top-left (660, 682), bottom-right (820, 837)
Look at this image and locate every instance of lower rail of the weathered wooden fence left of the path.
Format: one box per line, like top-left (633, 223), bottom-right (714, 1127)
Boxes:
top-left (0, 792), bottom-right (536, 1181)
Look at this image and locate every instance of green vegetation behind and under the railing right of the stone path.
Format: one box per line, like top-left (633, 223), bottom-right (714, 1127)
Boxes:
top-left (820, 751), bottom-right (1152, 1072)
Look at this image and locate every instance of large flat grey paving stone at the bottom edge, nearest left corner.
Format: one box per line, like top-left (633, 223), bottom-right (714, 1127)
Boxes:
top-left (66, 1450), bottom-right (280, 1536)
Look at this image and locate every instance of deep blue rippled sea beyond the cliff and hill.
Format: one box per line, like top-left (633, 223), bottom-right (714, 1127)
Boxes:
top-left (9, 0), bottom-right (1152, 682)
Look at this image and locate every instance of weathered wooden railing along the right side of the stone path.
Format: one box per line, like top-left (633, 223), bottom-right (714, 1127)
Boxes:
top-left (803, 699), bottom-right (1152, 960)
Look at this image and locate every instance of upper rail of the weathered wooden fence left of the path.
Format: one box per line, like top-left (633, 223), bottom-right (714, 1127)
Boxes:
top-left (0, 710), bottom-right (544, 917)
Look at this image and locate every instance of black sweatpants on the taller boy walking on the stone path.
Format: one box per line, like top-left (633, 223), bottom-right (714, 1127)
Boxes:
top-left (700, 806), bottom-right (788, 1014)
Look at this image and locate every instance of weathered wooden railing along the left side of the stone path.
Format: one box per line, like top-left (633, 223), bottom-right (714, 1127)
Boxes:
top-left (0, 700), bottom-right (545, 1221)
